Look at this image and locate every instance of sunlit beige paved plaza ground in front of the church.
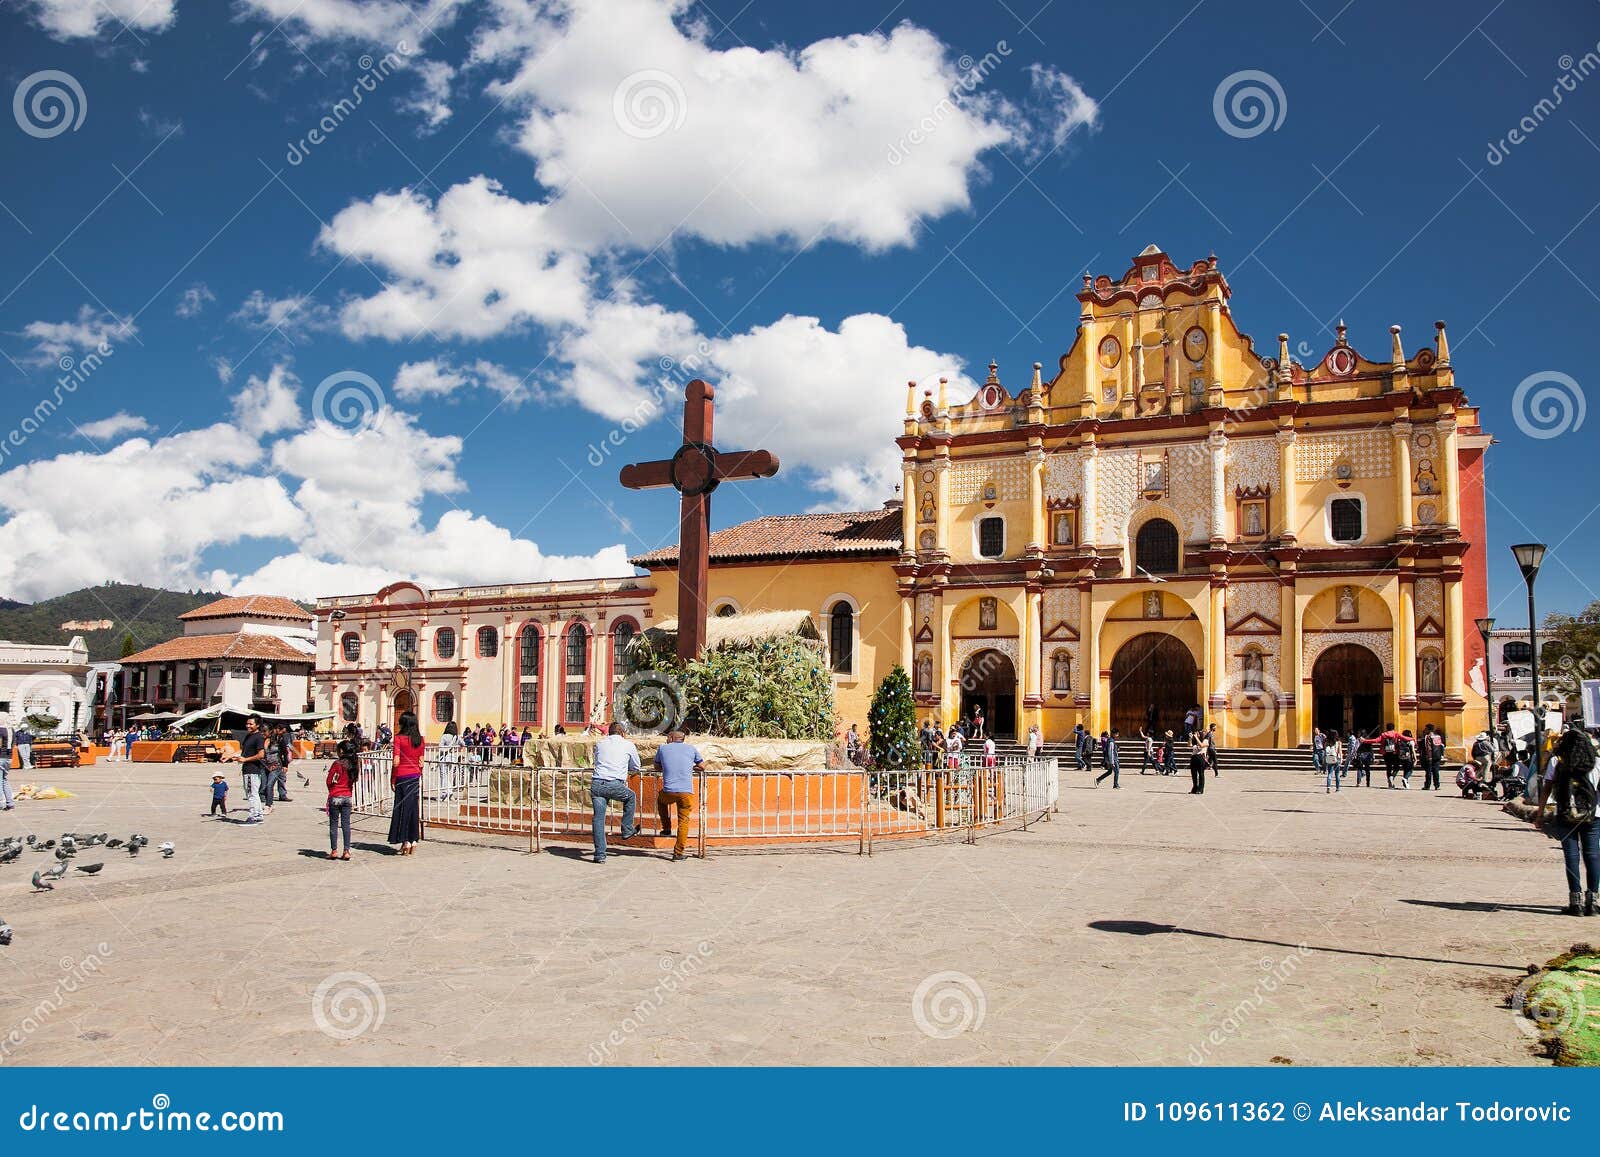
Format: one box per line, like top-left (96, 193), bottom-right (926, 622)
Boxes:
top-left (0, 765), bottom-right (1574, 1066)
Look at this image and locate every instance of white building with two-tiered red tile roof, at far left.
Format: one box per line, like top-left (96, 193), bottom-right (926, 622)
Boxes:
top-left (115, 595), bottom-right (315, 727)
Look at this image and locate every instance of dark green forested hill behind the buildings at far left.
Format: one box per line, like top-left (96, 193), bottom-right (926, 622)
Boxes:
top-left (0, 583), bottom-right (224, 663)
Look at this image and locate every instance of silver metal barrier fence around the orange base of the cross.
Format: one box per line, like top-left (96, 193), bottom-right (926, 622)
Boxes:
top-left (355, 747), bottom-right (1059, 856)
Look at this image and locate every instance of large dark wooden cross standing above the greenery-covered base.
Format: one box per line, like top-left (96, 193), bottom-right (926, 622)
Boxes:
top-left (619, 378), bottom-right (778, 663)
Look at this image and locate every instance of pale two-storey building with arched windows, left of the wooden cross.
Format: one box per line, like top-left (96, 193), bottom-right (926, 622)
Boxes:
top-left (317, 578), bottom-right (651, 738)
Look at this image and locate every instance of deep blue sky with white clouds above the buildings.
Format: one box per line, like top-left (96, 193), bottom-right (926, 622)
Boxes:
top-left (0, 0), bottom-right (1600, 633)
